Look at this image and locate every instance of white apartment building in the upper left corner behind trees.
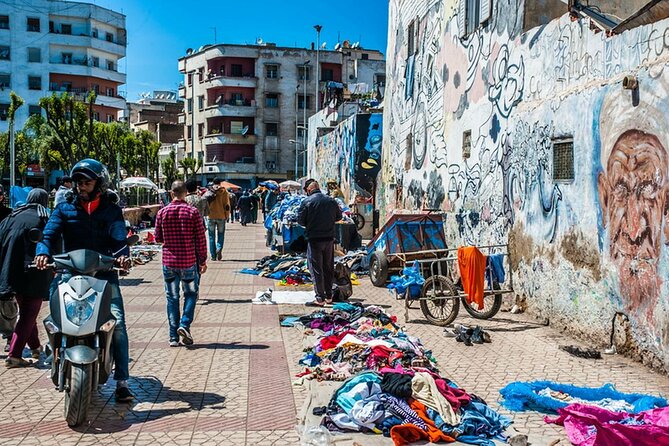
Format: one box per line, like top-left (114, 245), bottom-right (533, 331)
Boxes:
top-left (0, 0), bottom-right (126, 131)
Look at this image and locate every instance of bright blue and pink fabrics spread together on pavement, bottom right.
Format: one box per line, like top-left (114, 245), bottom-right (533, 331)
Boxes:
top-left (500, 381), bottom-right (669, 446)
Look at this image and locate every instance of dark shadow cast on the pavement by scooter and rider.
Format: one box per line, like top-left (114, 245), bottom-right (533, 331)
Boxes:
top-left (73, 376), bottom-right (226, 435)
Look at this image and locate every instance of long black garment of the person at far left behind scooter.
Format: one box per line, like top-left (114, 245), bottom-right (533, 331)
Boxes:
top-left (0, 204), bottom-right (53, 299)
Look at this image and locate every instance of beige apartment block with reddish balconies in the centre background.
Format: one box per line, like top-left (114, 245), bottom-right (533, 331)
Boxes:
top-left (179, 42), bottom-right (385, 185)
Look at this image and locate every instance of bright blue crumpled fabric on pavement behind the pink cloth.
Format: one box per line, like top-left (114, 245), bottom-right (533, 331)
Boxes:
top-left (499, 381), bottom-right (667, 413)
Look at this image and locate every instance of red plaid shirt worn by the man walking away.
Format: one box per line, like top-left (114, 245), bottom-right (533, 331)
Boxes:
top-left (155, 200), bottom-right (207, 269)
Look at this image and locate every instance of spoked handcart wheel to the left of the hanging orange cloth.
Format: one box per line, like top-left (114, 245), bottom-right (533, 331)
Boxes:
top-left (420, 275), bottom-right (460, 327)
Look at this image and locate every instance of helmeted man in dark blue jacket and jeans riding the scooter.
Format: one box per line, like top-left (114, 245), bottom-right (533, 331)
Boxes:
top-left (35, 159), bottom-right (133, 401)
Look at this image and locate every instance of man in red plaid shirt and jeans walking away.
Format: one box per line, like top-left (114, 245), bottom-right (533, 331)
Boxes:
top-left (156, 181), bottom-right (207, 347)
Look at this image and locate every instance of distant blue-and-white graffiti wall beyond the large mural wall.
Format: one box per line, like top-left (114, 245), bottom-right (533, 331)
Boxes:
top-left (309, 113), bottom-right (383, 203)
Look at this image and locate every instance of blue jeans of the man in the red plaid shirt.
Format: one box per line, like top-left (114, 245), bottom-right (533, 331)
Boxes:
top-left (163, 265), bottom-right (200, 341)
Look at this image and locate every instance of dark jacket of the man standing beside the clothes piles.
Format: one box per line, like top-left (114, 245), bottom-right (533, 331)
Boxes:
top-left (297, 191), bottom-right (342, 241)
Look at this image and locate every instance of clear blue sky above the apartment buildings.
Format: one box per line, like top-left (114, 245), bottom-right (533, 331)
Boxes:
top-left (88, 0), bottom-right (388, 102)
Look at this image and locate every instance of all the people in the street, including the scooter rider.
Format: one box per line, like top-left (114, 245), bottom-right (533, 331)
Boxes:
top-left (0, 159), bottom-right (341, 408)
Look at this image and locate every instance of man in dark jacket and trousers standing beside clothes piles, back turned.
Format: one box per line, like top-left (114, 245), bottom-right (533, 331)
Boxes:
top-left (297, 179), bottom-right (342, 307)
